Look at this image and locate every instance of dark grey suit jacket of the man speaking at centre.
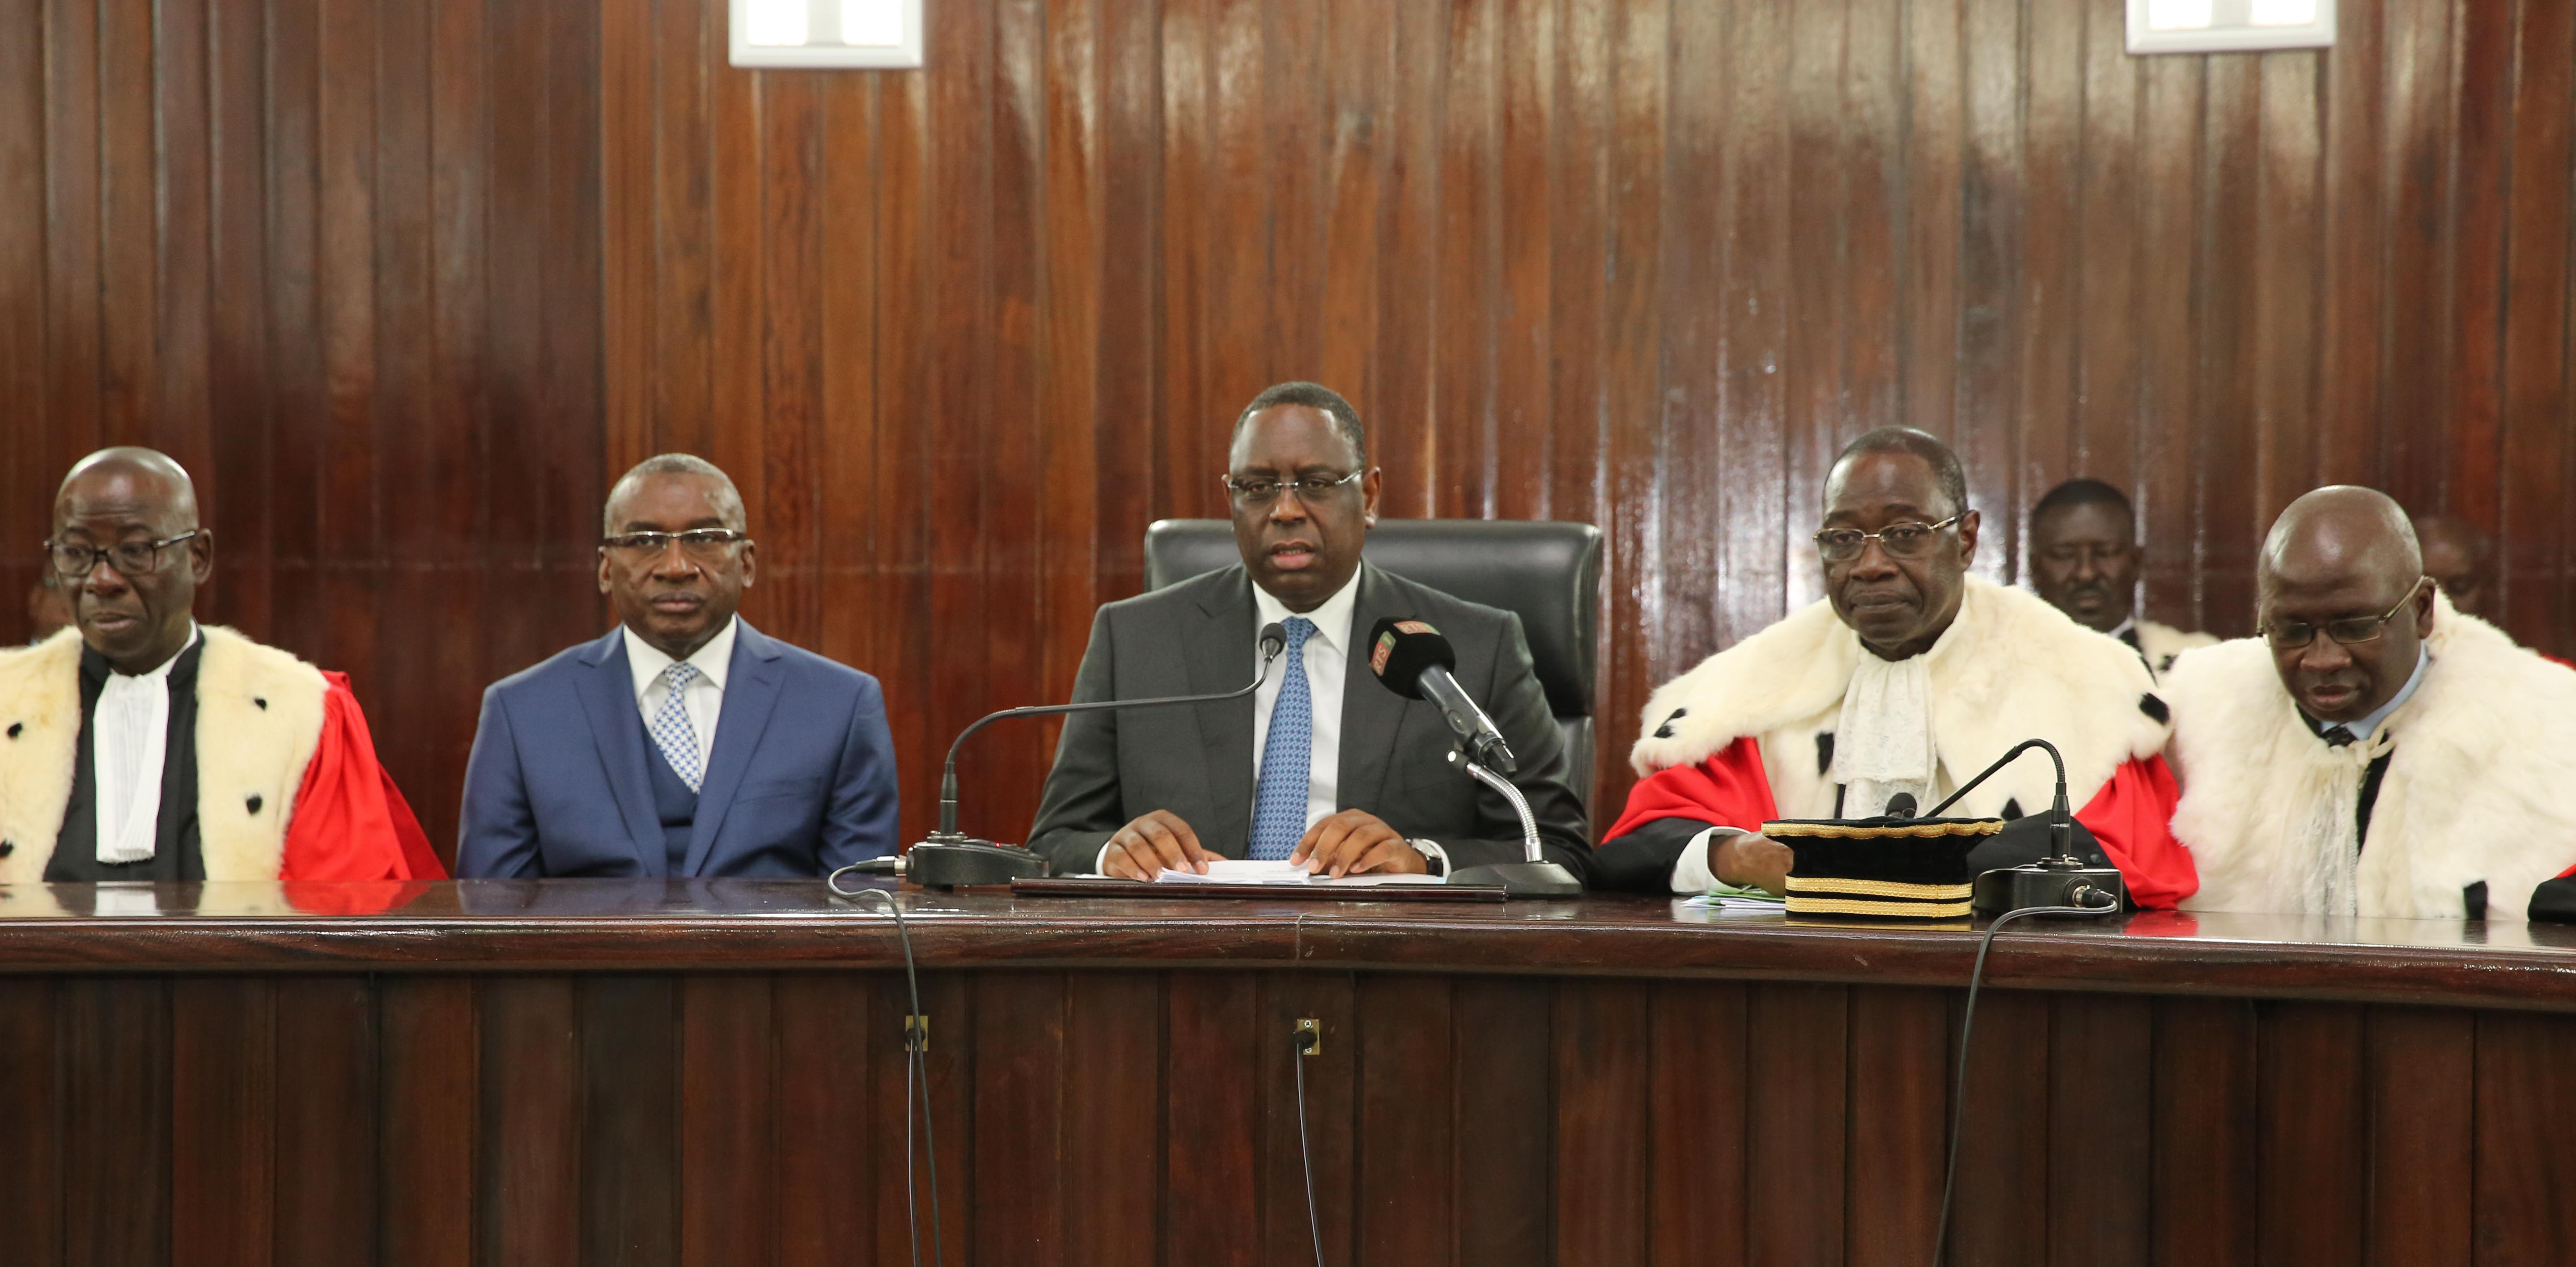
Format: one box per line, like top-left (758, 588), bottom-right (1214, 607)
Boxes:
top-left (1028, 564), bottom-right (1592, 876)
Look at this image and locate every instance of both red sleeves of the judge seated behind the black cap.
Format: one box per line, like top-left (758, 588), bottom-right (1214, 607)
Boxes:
top-left (1602, 734), bottom-right (2200, 909)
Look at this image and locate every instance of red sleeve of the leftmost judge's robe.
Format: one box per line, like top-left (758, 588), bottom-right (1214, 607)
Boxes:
top-left (278, 672), bottom-right (448, 886)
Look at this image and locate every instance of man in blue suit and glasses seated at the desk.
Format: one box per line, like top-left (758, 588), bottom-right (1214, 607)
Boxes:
top-left (456, 453), bottom-right (896, 878)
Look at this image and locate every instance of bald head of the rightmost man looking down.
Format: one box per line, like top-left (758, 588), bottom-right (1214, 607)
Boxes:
top-left (2254, 484), bottom-right (2434, 721)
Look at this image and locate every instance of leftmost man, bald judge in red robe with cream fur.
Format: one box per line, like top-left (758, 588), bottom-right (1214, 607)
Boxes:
top-left (0, 448), bottom-right (443, 883)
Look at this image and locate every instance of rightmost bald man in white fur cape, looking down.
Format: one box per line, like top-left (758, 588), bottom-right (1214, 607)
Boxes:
top-left (2164, 487), bottom-right (2576, 920)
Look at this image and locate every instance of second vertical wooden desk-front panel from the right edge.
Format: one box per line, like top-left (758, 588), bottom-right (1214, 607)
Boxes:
top-left (2344, 1007), bottom-right (2478, 1267)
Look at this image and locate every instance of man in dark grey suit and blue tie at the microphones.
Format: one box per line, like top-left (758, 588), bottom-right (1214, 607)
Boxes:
top-left (1028, 384), bottom-right (1592, 881)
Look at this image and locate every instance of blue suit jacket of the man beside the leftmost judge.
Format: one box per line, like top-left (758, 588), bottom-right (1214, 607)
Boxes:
top-left (456, 621), bottom-right (896, 878)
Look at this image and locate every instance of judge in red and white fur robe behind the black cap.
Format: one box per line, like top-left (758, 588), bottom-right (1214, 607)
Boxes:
top-left (1595, 428), bottom-right (2197, 917)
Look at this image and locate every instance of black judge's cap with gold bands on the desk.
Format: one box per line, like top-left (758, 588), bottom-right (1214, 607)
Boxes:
top-left (1762, 819), bottom-right (2004, 920)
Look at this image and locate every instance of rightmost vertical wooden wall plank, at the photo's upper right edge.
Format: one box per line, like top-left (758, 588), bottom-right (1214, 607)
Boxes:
top-left (2496, 5), bottom-right (2576, 654)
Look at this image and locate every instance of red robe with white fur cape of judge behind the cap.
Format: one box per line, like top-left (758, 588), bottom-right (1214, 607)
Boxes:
top-left (1595, 574), bottom-right (2197, 907)
